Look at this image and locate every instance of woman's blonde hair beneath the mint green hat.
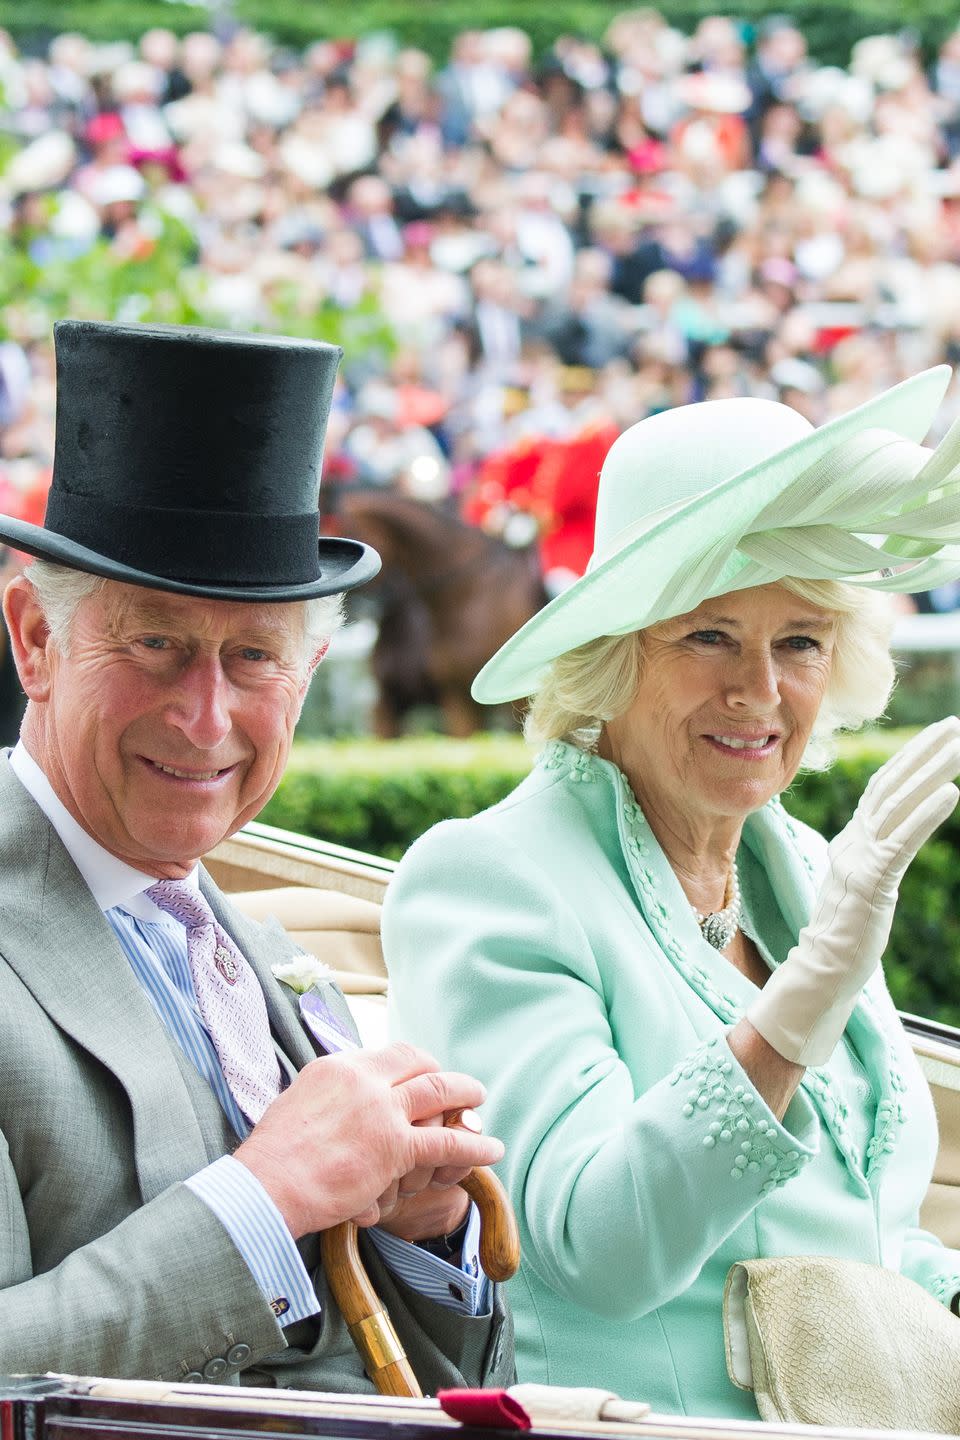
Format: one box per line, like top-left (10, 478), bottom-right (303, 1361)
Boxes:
top-left (524, 579), bottom-right (895, 770)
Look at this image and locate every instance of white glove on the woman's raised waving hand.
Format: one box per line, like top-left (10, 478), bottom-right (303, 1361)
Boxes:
top-left (747, 716), bottom-right (960, 1066)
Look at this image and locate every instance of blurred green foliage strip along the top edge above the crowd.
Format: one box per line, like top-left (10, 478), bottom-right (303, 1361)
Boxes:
top-left (0, 0), bottom-right (957, 65)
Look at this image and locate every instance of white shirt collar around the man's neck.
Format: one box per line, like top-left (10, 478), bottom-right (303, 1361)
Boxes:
top-left (10, 740), bottom-right (200, 922)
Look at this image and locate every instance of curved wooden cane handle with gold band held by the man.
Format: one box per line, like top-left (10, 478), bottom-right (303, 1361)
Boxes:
top-left (320, 1112), bottom-right (520, 1397)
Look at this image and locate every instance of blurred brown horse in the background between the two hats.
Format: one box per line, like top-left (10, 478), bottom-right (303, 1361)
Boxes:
top-left (328, 487), bottom-right (547, 739)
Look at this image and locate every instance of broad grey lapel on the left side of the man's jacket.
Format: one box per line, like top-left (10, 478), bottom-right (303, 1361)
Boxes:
top-left (0, 757), bottom-right (207, 1201)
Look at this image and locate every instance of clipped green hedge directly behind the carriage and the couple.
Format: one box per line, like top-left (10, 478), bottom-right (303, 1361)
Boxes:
top-left (261, 732), bottom-right (960, 1025)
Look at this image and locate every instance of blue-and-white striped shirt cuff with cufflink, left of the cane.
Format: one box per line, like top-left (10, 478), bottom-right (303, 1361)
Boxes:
top-left (184, 1155), bottom-right (320, 1325)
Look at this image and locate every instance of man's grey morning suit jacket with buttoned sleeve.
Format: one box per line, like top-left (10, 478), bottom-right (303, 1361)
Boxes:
top-left (0, 753), bottom-right (512, 1392)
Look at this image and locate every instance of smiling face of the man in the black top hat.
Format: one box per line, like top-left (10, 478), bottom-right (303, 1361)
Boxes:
top-left (22, 580), bottom-right (305, 878)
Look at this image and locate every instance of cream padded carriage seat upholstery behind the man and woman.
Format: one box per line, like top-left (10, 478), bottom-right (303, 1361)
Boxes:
top-left (230, 869), bottom-right (960, 1248)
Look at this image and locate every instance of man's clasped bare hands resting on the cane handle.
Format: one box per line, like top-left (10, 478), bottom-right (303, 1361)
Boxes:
top-left (236, 1044), bottom-right (504, 1240)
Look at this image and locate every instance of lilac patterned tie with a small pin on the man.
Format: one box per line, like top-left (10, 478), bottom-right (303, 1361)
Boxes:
top-left (145, 880), bottom-right (281, 1125)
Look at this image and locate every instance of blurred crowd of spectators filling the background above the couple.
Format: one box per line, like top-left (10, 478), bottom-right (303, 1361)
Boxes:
top-left (0, 9), bottom-right (960, 606)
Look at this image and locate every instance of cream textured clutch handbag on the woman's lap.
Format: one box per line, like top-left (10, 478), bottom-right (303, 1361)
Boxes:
top-left (724, 1256), bottom-right (960, 1434)
